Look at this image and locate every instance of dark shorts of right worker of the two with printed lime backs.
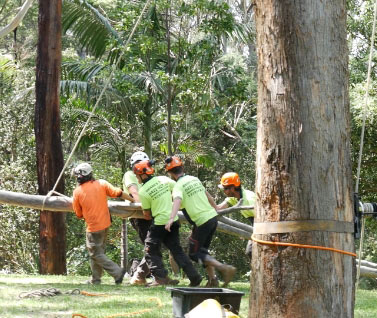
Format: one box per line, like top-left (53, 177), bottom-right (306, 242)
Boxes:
top-left (189, 217), bottom-right (217, 264)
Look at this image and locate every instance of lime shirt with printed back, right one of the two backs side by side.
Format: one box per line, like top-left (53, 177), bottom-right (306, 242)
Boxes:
top-left (173, 176), bottom-right (217, 226)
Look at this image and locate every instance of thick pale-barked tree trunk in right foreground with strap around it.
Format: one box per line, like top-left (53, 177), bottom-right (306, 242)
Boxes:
top-left (249, 0), bottom-right (355, 318)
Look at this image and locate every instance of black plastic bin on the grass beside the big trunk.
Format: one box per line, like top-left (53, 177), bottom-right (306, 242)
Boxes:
top-left (167, 287), bottom-right (245, 318)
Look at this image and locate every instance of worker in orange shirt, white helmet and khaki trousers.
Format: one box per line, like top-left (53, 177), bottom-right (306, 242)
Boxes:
top-left (72, 163), bottom-right (134, 284)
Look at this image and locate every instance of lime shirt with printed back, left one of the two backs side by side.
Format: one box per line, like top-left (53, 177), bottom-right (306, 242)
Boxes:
top-left (139, 176), bottom-right (178, 225)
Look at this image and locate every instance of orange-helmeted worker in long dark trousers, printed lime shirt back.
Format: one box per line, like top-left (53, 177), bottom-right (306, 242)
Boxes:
top-left (133, 160), bottom-right (202, 287)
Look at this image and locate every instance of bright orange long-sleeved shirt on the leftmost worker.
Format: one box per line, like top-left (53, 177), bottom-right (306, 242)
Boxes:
top-left (72, 179), bottom-right (122, 232)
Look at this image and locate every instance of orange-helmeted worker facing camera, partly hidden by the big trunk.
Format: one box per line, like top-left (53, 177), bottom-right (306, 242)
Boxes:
top-left (217, 172), bottom-right (256, 260)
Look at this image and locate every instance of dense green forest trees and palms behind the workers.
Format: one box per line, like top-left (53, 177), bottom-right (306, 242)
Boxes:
top-left (0, 0), bottom-right (377, 288)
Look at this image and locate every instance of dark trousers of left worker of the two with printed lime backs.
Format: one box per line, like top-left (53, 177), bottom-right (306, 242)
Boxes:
top-left (145, 221), bottom-right (199, 280)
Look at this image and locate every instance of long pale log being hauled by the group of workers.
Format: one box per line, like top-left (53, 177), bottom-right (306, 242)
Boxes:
top-left (0, 190), bottom-right (253, 239)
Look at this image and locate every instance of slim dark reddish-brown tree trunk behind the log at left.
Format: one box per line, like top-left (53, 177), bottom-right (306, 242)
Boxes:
top-left (34, 0), bottom-right (66, 274)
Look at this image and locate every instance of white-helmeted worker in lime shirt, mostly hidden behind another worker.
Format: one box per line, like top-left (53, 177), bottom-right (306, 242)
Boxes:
top-left (123, 151), bottom-right (152, 285)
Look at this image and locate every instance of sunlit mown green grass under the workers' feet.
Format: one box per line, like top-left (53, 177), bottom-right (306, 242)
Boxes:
top-left (0, 274), bottom-right (377, 318)
